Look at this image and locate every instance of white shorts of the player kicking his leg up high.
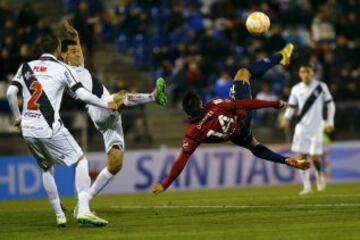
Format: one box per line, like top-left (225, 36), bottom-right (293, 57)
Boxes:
top-left (88, 105), bottom-right (125, 153)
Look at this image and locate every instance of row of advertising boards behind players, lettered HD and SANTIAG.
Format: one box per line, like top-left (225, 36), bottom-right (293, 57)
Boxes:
top-left (0, 142), bottom-right (360, 200)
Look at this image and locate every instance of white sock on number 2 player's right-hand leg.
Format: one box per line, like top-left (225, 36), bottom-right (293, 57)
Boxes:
top-left (75, 157), bottom-right (91, 213)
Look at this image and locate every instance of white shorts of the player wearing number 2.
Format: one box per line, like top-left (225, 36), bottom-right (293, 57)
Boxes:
top-left (24, 126), bottom-right (84, 170)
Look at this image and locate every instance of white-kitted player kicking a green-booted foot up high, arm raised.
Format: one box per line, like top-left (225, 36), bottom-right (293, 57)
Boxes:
top-left (62, 21), bottom-right (167, 218)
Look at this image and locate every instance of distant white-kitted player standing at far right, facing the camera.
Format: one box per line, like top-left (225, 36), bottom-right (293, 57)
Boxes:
top-left (280, 64), bottom-right (335, 195)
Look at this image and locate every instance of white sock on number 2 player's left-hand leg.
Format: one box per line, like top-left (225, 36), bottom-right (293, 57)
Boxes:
top-left (42, 168), bottom-right (65, 215)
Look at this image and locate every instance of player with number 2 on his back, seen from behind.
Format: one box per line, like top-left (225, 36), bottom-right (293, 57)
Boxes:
top-left (7, 35), bottom-right (117, 227)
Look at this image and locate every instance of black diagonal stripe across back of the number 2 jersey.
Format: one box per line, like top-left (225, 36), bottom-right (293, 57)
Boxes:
top-left (21, 63), bottom-right (55, 128)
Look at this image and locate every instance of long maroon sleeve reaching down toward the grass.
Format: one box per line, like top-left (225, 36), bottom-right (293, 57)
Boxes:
top-left (161, 136), bottom-right (200, 189)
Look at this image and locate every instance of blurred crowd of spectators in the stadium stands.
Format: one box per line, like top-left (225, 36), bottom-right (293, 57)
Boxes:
top-left (0, 0), bottom-right (360, 153)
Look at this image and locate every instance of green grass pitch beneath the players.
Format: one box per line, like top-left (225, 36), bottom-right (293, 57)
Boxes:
top-left (0, 183), bottom-right (360, 240)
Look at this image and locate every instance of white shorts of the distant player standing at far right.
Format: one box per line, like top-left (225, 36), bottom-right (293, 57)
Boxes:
top-left (291, 131), bottom-right (323, 156)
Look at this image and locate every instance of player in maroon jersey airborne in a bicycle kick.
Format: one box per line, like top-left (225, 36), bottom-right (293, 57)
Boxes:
top-left (152, 44), bottom-right (310, 194)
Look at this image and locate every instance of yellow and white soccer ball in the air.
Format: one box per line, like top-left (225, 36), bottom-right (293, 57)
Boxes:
top-left (246, 12), bottom-right (270, 34)
